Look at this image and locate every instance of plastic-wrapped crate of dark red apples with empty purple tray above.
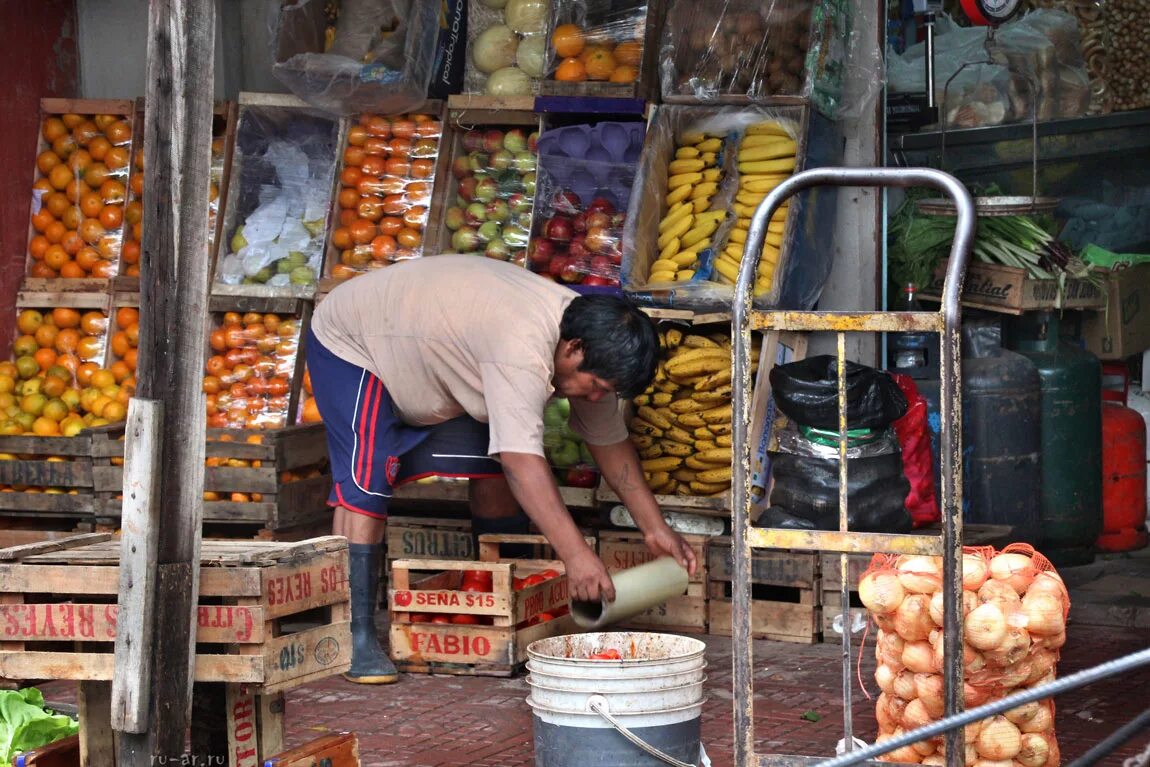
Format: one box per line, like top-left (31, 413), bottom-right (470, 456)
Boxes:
top-left (527, 122), bottom-right (644, 290)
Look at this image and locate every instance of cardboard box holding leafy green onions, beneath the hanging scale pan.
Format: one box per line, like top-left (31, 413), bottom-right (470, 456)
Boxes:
top-left (922, 261), bottom-right (1106, 314)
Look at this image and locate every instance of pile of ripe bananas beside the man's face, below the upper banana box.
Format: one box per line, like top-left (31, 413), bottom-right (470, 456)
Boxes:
top-left (630, 327), bottom-right (759, 496)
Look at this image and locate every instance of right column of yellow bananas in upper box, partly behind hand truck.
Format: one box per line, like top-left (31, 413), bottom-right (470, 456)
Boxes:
top-left (715, 120), bottom-right (797, 293)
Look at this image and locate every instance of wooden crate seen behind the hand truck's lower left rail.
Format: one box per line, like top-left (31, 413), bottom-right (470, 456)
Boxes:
top-left (707, 537), bottom-right (822, 644)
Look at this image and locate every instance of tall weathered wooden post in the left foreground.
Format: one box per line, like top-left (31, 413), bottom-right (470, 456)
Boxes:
top-left (118, 0), bottom-right (215, 767)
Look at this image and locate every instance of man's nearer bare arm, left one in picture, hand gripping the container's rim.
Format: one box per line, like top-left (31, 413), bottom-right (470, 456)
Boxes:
top-left (499, 452), bottom-right (616, 601)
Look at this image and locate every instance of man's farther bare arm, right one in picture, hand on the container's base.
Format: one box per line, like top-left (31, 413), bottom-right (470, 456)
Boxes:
top-left (588, 439), bottom-right (698, 575)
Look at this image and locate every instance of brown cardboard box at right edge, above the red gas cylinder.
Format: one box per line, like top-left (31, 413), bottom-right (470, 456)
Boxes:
top-left (1082, 263), bottom-right (1150, 360)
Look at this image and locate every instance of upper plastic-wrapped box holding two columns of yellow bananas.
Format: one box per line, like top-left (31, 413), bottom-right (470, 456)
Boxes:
top-left (622, 106), bottom-right (834, 308)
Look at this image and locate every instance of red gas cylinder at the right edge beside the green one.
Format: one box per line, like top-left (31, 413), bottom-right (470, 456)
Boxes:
top-left (1098, 402), bottom-right (1147, 551)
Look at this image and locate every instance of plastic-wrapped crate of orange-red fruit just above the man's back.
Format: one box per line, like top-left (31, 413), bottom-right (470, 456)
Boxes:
top-left (327, 114), bottom-right (443, 281)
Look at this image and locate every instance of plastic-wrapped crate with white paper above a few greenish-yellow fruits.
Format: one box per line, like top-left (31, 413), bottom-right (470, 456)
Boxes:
top-left (215, 105), bottom-right (339, 290)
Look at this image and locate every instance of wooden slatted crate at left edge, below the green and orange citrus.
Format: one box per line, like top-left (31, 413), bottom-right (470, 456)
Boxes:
top-left (0, 431), bottom-right (95, 522)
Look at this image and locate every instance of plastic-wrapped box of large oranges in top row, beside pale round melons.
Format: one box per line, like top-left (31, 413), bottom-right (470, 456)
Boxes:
top-left (547, 0), bottom-right (654, 85)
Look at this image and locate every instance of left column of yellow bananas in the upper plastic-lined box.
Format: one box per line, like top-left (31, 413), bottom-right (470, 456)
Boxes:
top-left (647, 133), bottom-right (727, 284)
